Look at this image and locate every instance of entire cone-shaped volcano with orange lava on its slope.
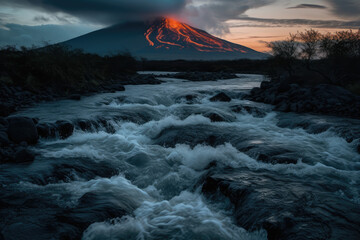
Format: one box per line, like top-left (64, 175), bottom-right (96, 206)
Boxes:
top-left (62, 18), bottom-right (267, 60)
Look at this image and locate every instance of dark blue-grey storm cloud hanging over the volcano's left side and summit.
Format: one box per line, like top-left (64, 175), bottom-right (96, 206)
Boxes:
top-left (0, 0), bottom-right (186, 23)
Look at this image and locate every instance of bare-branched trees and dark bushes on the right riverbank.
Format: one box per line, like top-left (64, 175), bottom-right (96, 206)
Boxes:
top-left (268, 29), bottom-right (360, 90)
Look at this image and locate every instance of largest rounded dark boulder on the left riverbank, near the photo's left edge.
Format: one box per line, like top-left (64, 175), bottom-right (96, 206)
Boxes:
top-left (7, 117), bottom-right (39, 144)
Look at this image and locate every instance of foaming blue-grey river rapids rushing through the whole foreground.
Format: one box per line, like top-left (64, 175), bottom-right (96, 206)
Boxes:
top-left (0, 75), bottom-right (360, 239)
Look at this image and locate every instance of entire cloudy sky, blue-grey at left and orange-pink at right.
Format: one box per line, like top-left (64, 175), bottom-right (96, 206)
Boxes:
top-left (0, 0), bottom-right (360, 51)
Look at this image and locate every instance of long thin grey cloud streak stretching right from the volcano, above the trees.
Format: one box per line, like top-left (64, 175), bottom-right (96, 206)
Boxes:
top-left (231, 17), bottom-right (360, 29)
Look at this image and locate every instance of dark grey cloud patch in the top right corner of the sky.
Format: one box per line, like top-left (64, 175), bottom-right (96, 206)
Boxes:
top-left (326, 0), bottom-right (360, 19)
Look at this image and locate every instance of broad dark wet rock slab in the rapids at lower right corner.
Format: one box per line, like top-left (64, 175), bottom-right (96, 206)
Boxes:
top-left (202, 169), bottom-right (360, 240)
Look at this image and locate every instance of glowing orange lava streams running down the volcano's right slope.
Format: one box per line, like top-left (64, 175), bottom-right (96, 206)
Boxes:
top-left (144, 18), bottom-right (246, 53)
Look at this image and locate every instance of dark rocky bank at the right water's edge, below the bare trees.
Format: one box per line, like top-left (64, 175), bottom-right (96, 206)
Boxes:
top-left (247, 81), bottom-right (360, 118)
